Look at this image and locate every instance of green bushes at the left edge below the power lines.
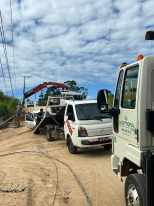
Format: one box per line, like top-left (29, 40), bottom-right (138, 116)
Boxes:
top-left (0, 90), bottom-right (20, 118)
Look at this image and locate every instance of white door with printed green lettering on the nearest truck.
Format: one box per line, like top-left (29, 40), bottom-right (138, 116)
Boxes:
top-left (113, 65), bottom-right (139, 144)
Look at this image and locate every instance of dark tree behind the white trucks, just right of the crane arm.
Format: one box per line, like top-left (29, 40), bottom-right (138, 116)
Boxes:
top-left (64, 80), bottom-right (88, 99)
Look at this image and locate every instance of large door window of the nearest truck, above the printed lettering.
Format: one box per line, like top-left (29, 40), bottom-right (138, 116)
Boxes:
top-left (121, 66), bottom-right (139, 109)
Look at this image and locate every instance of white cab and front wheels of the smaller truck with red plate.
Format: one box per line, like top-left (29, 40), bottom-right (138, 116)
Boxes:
top-left (64, 100), bottom-right (112, 154)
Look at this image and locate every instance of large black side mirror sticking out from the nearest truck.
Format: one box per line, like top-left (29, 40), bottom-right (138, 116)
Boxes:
top-left (97, 89), bottom-right (108, 111)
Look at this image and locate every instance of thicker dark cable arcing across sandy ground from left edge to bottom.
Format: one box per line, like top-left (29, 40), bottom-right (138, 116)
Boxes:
top-left (0, 150), bottom-right (92, 206)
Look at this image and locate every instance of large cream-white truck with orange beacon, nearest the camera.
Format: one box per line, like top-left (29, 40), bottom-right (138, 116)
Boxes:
top-left (97, 31), bottom-right (154, 206)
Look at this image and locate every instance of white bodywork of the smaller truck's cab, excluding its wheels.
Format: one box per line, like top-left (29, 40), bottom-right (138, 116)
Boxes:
top-left (64, 100), bottom-right (112, 148)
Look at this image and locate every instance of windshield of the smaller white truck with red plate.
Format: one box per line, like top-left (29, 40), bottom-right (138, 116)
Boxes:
top-left (75, 103), bottom-right (111, 120)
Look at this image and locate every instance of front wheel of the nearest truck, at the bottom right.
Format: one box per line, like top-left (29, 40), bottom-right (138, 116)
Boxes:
top-left (125, 174), bottom-right (146, 206)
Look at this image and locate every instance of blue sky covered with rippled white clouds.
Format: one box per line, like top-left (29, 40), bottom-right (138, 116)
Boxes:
top-left (0, 0), bottom-right (154, 104)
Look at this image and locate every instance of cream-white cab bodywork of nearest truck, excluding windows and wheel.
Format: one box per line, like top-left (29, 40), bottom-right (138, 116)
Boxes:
top-left (111, 56), bottom-right (154, 179)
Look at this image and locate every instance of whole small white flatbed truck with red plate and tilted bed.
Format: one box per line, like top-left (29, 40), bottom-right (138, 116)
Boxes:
top-left (33, 96), bottom-right (112, 154)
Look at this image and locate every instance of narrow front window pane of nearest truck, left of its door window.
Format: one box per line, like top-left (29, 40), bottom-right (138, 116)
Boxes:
top-left (114, 70), bottom-right (123, 108)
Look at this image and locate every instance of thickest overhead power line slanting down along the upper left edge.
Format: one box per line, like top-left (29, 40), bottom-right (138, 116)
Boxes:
top-left (0, 10), bottom-right (14, 96)
